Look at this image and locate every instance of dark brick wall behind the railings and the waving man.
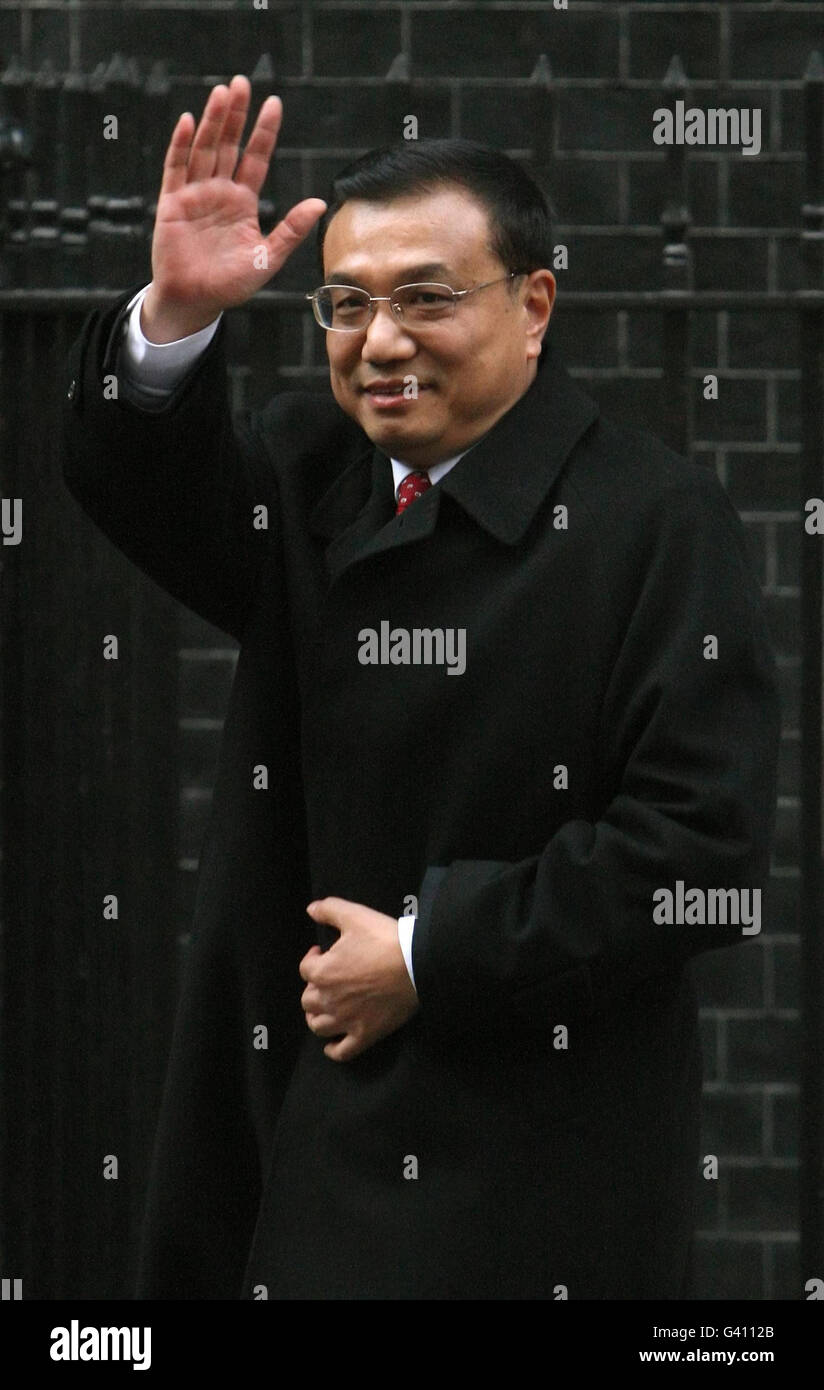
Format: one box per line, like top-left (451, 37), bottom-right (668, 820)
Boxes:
top-left (0, 0), bottom-right (824, 1300)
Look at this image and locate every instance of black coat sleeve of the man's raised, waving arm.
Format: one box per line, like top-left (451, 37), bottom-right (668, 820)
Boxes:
top-left (63, 286), bottom-right (279, 639)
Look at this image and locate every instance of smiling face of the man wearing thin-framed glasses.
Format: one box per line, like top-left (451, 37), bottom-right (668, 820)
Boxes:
top-left (318, 185), bottom-right (554, 468)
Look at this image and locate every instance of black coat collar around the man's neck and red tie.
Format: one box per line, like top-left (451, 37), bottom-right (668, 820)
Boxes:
top-left (308, 338), bottom-right (599, 571)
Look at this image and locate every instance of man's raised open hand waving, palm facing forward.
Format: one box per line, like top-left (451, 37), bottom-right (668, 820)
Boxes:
top-left (140, 75), bottom-right (327, 342)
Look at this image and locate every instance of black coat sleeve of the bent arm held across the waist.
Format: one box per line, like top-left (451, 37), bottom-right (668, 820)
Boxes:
top-left (413, 470), bottom-right (780, 1030)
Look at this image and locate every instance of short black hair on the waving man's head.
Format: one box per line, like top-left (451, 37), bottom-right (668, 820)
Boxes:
top-left (315, 139), bottom-right (554, 275)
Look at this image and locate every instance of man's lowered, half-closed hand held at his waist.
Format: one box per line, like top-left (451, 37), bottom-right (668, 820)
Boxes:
top-left (300, 898), bottom-right (420, 1062)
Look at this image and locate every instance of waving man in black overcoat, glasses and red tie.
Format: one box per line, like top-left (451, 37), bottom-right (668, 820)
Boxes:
top-left (65, 76), bottom-right (778, 1300)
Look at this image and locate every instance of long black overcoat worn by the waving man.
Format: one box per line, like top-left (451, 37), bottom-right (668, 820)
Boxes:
top-left (64, 289), bottom-right (778, 1300)
